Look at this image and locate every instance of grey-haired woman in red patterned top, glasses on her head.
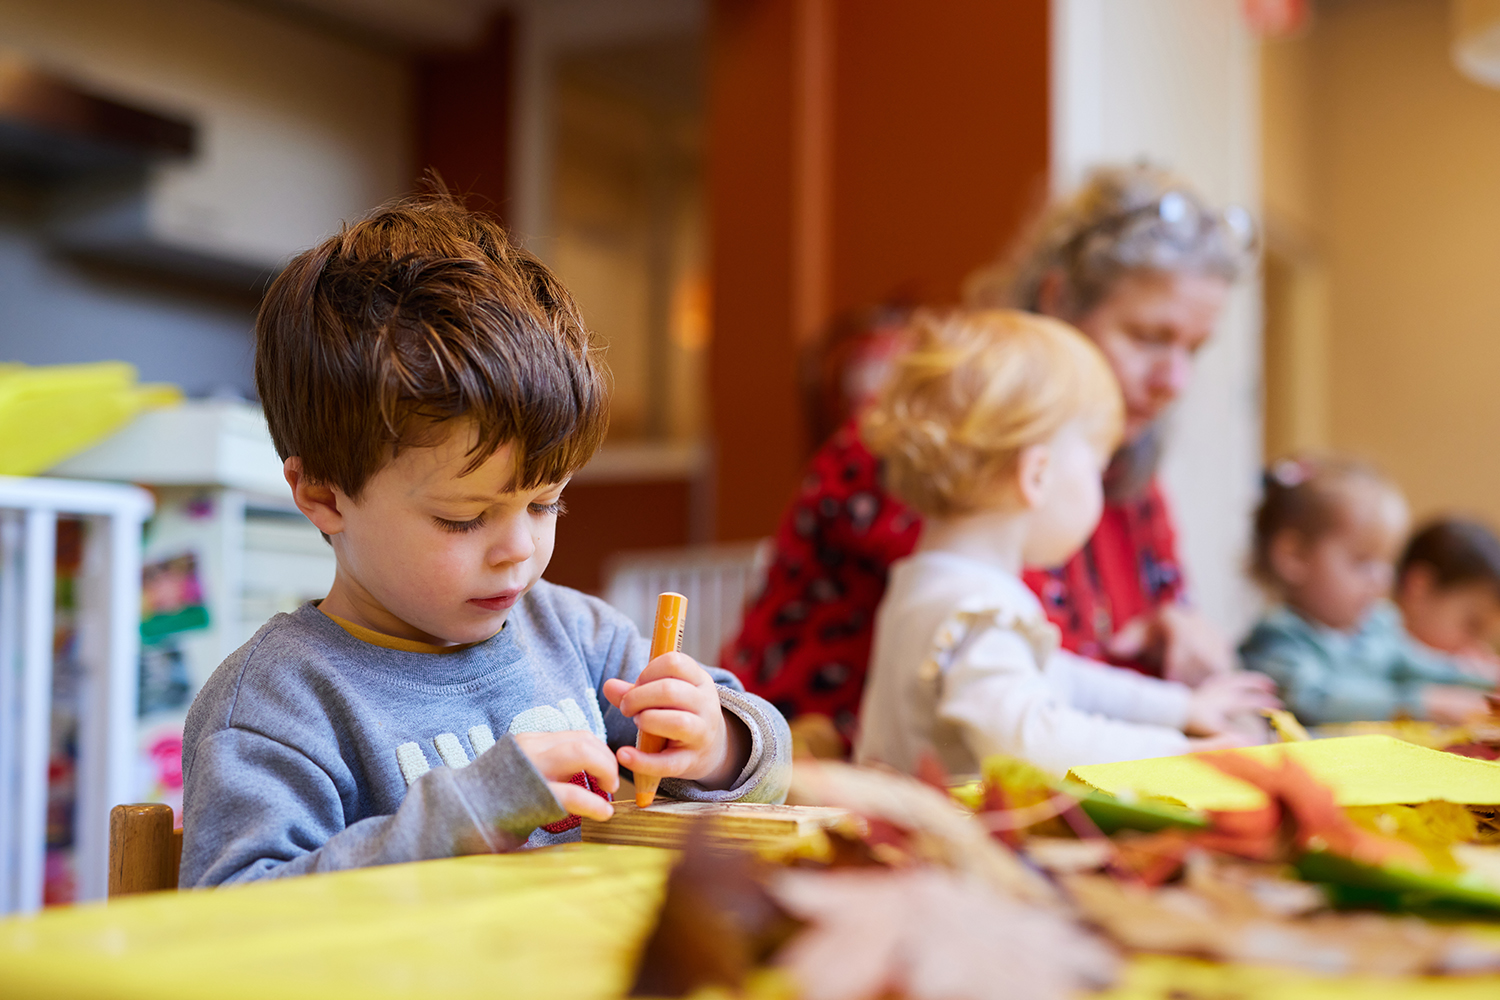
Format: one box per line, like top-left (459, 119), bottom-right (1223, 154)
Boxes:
top-left (720, 165), bottom-right (1253, 739)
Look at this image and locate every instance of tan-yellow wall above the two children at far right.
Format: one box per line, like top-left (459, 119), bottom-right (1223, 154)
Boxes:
top-left (1263, 0), bottom-right (1500, 522)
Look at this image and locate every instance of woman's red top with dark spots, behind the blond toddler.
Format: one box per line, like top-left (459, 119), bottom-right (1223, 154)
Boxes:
top-left (720, 423), bottom-right (1182, 738)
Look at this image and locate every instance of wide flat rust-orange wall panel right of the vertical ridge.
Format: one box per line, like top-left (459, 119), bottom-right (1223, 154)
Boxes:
top-left (831, 0), bottom-right (1047, 312)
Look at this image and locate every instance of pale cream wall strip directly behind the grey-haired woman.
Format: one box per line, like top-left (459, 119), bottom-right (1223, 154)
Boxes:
top-left (1052, 0), bottom-right (1262, 634)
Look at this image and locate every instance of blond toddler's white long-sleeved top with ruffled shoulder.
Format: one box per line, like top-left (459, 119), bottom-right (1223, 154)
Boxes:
top-left (855, 552), bottom-right (1191, 777)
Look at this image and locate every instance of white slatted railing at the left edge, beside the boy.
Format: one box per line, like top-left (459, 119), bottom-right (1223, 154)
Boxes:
top-left (0, 477), bottom-right (153, 913)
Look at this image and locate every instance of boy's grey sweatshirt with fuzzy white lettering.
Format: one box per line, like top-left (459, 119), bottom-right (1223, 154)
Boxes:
top-left (180, 582), bottom-right (791, 886)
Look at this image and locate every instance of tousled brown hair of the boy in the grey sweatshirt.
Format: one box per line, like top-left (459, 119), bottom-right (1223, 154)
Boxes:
top-left (255, 184), bottom-right (609, 498)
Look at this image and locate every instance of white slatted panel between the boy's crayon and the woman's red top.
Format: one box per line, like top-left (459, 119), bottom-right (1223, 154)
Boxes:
top-left (605, 538), bottom-right (771, 666)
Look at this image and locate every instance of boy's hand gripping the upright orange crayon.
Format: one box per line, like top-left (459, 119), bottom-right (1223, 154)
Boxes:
top-left (605, 652), bottom-right (750, 789)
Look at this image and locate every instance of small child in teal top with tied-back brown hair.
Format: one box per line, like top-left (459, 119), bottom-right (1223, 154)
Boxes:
top-left (1239, 459), bottom-right (1490, 724)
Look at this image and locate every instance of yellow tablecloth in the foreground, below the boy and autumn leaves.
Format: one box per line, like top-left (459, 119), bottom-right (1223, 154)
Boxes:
top-left (0, 844), bottom-right (1500, 1000)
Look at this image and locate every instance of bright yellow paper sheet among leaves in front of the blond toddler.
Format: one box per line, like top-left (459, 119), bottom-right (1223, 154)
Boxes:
top-left (1068, 736), bottom-right (1500, 810)
